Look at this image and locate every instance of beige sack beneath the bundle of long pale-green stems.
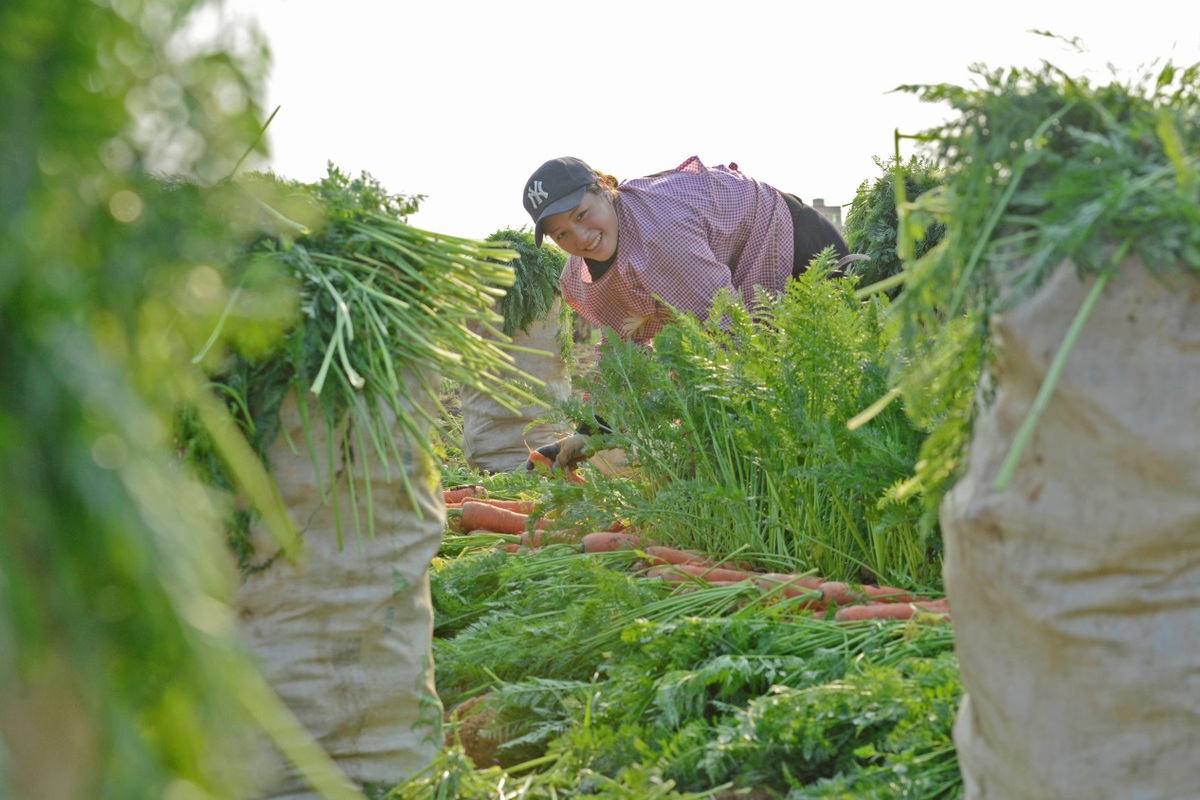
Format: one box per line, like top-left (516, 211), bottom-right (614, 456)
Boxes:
top-left (239, 383), bottom-right (445, 799)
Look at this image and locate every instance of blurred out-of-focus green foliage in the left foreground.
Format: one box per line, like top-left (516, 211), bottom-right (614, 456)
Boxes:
top-left (0, 0), bottom-right (360, 798)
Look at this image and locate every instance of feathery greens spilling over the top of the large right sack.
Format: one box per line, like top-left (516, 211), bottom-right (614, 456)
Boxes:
top-left (890, 38), bottom-right (1200, 513)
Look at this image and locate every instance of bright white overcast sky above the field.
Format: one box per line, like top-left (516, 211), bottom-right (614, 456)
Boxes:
top-left (213, 0), bottom-right (1200, 239)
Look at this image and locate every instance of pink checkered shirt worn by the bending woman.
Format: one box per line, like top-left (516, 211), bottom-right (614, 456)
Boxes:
top-left (560, 156), bottom-right (793, 342)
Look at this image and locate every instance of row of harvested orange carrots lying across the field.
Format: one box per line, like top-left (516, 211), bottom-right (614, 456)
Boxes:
top-left (444, 486), bottom-right (950, 622)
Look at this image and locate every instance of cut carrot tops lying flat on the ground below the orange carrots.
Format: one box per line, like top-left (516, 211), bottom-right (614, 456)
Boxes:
top-left (388, 549), bottom-right (961, 799)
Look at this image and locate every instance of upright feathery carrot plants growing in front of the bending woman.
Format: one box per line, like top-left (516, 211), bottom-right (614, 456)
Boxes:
top-left (552, 260), bottom-right (940, 585)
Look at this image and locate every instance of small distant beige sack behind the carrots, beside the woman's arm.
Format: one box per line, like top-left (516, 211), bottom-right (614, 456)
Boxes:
top-left (460, 299), bottom-right (571, 473)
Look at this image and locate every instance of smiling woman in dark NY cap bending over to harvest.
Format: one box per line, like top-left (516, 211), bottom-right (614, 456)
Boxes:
top-left (523, 156), bottom-right (848, 468)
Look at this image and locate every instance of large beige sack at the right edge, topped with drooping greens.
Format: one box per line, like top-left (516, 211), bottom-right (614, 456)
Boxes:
top-left (941, 263), bottom-right (1200, 800)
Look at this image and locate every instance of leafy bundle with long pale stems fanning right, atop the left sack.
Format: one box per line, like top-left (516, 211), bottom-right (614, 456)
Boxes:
top-left (178, 164), bottom-right (542, 570)
